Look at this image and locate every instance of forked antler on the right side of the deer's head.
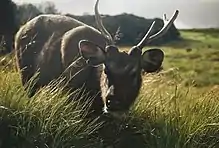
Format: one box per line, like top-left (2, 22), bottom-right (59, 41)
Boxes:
top-left (137, 10), bottom-right (179, 49)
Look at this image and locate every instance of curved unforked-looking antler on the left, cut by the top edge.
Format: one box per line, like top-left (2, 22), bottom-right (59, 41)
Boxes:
top-left (95, 0), bottom-right (114, 44)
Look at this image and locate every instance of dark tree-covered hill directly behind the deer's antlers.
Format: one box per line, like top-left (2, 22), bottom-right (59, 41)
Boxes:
top-left (66, 13), bottom-right (180, 45)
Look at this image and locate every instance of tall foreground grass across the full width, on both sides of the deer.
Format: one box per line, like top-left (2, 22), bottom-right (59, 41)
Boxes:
top-left (0, 57), bottom-right (219, 148)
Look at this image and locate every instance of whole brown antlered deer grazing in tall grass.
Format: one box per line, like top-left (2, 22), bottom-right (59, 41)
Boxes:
top-left (15, 0), bottom-right (179, 113)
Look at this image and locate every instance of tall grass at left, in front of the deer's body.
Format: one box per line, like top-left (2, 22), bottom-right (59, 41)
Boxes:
top-left (0, 64), bottom-right (106, 147)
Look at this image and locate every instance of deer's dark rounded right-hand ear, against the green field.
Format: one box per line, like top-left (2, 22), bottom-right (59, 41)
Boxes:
top-left (141, 48), bottom-right (164, 72)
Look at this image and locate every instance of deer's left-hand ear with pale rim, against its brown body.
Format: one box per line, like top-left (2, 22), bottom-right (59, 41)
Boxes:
top-left (78, 40), bottom-right (106, 66)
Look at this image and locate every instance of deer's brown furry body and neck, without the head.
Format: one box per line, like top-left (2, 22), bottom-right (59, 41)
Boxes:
top-left (15, 15), bottom-right (106, 112)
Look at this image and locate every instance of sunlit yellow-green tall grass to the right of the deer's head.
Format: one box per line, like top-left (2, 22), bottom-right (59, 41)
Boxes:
top-left (133, 72), bottom-right (219, 148)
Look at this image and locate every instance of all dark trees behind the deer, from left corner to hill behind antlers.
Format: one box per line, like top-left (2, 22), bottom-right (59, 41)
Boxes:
top-left (0, 0), bottom-right (180, 52)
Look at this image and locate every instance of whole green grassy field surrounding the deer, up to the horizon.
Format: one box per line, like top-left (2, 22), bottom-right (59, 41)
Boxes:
top-left (0, 30), bottom-right (219, 148)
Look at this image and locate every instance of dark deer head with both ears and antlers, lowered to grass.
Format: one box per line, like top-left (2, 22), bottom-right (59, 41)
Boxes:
top-left (79, 0), bottom-right (179, 112)
